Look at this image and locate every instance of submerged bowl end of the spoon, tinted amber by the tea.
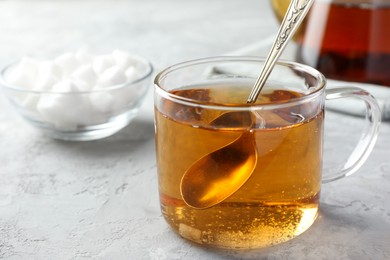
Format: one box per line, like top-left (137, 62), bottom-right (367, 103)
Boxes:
top-left (180, 112), bottom-right (257, 209)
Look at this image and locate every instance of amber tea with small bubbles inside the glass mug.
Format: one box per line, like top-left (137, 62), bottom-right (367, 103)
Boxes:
top-left (156, 86), bottom-right (323, 248)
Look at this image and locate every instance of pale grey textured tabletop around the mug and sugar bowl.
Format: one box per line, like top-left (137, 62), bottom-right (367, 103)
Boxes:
top-left (0, 0), bottom-right (390, 260)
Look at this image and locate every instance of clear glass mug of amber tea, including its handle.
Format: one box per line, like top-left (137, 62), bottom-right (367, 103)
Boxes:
top-left (154, 57), bottom-right (380, 249)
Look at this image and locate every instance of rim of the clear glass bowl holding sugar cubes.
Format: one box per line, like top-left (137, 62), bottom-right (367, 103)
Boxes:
top-left (0, 54), bottom-right (154, 95)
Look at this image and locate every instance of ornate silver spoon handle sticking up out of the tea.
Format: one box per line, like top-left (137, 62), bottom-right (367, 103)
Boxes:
top-left (247, 0), bottom-right (314, 104)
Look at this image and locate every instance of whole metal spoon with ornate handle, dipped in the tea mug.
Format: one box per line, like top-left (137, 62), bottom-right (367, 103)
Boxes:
top-left (180, 0), bottom-right (314, 209)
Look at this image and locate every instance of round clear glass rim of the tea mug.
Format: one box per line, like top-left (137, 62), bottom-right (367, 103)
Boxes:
top-left (153, 56), bottom-right (326, 110)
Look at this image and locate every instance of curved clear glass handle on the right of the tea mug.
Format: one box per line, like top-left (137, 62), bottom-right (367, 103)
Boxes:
top-left (322, 87), bottom-right (381, 183)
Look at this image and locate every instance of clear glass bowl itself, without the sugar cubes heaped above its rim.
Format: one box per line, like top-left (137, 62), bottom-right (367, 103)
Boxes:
top-left (0, 55), bottom-right (153, 141)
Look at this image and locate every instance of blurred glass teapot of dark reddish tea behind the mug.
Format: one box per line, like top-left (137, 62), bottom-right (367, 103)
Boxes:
top-left (272, 0), bottom-right (390, 87)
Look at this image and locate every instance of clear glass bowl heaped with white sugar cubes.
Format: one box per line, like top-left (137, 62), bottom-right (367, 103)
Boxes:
top-left (0, 50), bottom-right (153, 141)
